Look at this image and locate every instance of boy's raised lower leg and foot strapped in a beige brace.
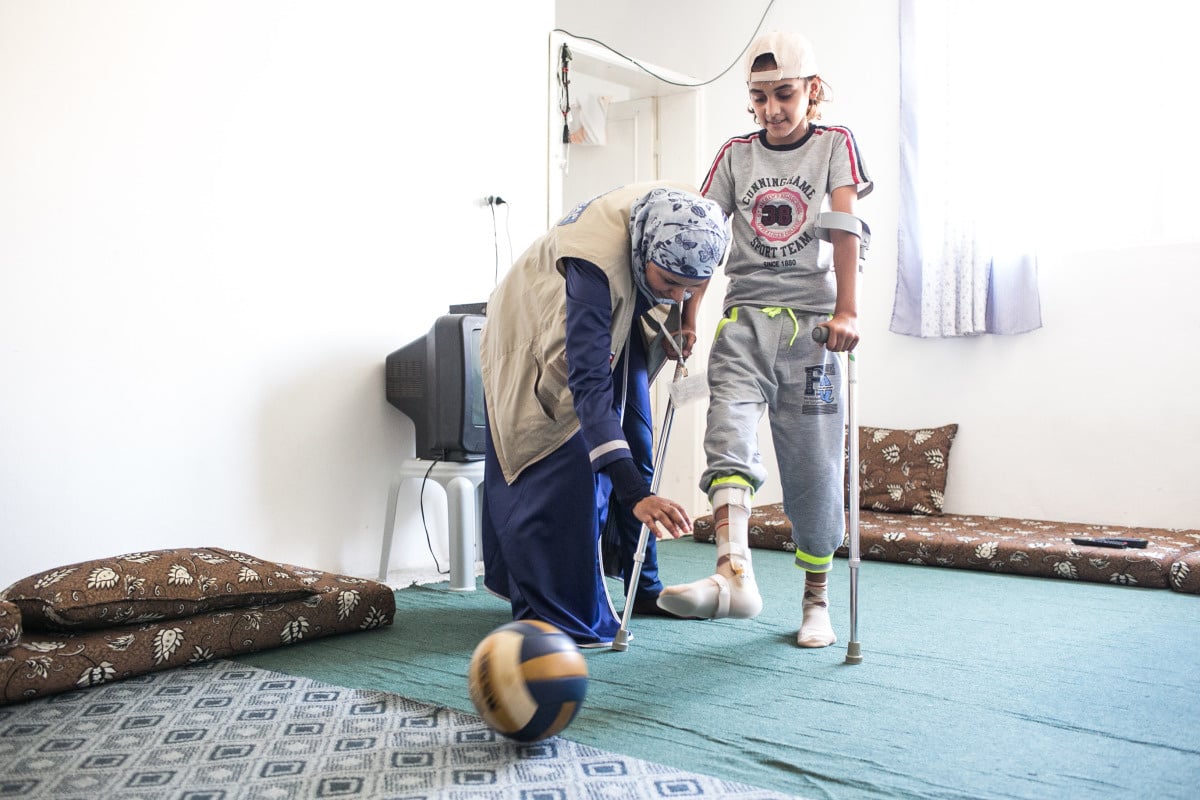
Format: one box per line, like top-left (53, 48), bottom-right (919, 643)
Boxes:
top-left (659, 487), bottom-right (762, 619)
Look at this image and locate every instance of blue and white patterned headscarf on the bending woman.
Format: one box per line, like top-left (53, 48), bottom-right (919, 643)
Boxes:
top-left (629, 187), bottom-right (730, 303)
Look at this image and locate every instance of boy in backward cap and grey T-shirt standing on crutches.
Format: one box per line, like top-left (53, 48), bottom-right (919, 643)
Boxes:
top-left (659, 32), bottom-right (872, 648)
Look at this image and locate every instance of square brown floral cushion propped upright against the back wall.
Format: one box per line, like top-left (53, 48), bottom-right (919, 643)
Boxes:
top-left (858, 425), bottom-right (959, 515)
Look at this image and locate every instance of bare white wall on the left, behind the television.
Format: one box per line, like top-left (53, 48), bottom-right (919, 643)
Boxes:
top-left (0, 0), bottom-right (553, 587)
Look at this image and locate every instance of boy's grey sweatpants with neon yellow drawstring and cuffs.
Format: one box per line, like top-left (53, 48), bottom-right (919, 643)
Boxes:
top-left (700, 306), bottom-right (846, 572)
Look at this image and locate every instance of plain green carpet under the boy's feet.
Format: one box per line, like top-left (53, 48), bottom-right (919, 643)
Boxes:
top-left (239, 539), bottom-right (1200, 799)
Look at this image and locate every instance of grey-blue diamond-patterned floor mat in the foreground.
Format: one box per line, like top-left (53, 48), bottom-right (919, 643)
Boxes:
top-left (0, 661), bottom-right (806, 800)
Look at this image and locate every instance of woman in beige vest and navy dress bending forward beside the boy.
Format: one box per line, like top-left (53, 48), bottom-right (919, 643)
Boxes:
top-left (481, 182), bottom-right (728, 646)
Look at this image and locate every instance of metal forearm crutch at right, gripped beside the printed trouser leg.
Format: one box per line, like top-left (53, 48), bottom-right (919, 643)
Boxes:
top-left (812, 211), bottom-right (871, 664)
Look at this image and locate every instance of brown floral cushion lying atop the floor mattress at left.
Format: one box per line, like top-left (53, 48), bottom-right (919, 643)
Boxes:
top-left (0, 547), bottom-right (313, 632)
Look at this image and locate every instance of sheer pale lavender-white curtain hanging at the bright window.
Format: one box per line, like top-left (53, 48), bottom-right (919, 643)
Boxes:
top-left (890, 0), bottom-right (1042, 337)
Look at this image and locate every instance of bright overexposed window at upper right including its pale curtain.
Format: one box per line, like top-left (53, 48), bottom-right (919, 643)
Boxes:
top-left (892, 0), bottom-right (1200, 336)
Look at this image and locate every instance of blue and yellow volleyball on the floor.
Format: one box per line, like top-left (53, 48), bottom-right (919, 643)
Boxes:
top-left (467, 619), bottom-right (588, 741)
